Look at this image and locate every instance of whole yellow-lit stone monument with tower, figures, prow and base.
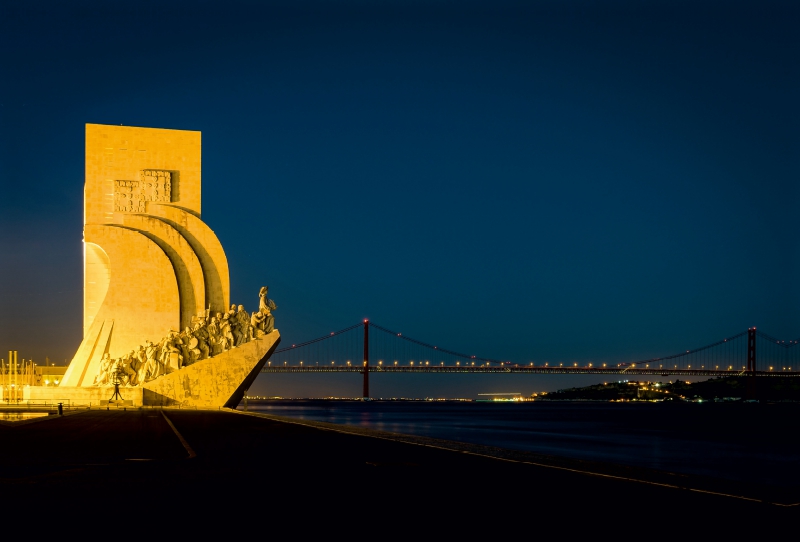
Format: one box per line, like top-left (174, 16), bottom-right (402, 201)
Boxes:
top-left (30, 124), bottom-right (280, 407)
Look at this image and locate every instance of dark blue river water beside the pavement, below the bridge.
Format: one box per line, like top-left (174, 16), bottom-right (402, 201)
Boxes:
top-left (244, 400), bottom-right (800, 486)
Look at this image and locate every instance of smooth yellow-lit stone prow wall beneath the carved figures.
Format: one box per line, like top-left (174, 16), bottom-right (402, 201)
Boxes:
top-left (143, 330), bottom-right (281, 408)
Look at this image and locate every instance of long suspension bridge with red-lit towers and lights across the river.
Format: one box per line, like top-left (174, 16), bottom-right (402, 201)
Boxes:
top-left (261, 320), bottom-right (800, 397)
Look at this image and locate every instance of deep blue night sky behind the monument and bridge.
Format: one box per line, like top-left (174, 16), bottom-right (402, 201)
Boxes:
top-left (0, 0), bottom-right (800, 397)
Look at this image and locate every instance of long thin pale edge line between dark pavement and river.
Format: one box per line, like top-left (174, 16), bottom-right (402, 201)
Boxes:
top-left (229, 409), bottom-right (800, 507)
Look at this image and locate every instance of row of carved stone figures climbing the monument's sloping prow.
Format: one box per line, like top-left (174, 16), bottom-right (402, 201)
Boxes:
top-left (92, 286), bottom-right (278, 386)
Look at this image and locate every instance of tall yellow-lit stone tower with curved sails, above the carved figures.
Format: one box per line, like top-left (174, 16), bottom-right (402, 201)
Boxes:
top-left (62, 124), bottom-right (230, 386)
